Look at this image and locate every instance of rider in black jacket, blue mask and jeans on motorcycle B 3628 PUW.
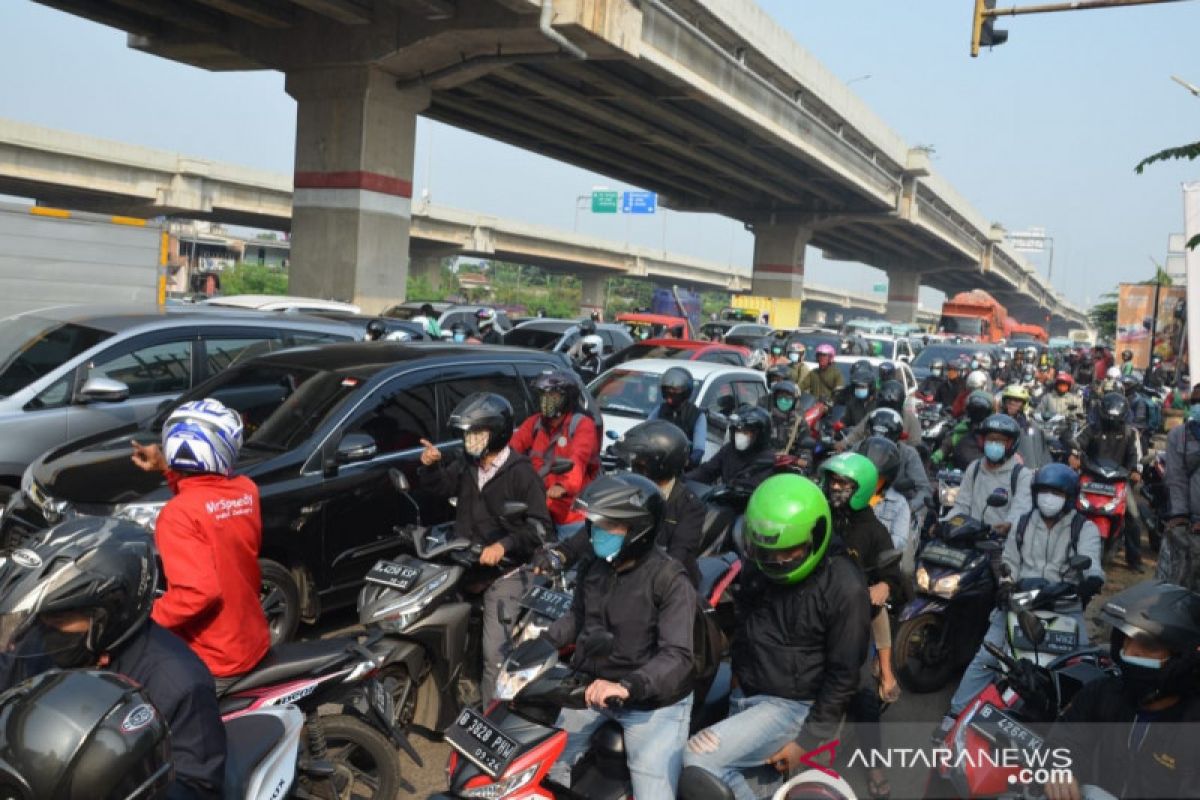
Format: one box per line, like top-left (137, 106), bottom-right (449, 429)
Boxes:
top-left (542, 474), bottom-right (696, 798)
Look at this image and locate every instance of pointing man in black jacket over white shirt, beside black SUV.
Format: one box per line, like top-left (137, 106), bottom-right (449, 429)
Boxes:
top-left (418, 392), bottom-right (553, 703)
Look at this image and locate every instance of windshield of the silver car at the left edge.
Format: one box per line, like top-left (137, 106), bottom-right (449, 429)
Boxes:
top-left (0, 314), bottom-right (113, 397)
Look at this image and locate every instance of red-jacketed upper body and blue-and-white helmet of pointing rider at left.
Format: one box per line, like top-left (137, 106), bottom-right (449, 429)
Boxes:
top-left (133, 399), bottom-right (271, 693)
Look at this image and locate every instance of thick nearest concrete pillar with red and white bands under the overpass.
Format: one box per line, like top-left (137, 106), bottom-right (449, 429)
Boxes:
top-left (287, 66), bottom-right (430, 314)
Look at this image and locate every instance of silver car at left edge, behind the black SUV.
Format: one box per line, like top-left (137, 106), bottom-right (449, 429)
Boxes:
top-left (0, 305), bottom-right (360, 488)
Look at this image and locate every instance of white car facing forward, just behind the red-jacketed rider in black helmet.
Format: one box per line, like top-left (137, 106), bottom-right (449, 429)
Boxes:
top-left (588, 359), bottom-right (767, 458)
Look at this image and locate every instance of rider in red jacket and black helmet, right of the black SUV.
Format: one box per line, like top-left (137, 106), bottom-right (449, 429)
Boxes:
top-left (509, 369), bottom-right (600, 541)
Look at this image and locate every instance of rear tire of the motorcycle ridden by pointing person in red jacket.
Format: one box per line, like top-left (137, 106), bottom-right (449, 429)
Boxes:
top-left (312, 714), bottom-right (401, 800)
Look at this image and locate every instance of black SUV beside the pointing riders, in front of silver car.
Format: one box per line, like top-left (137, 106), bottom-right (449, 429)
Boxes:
top-left (0, 342), bottom-right (600, 639)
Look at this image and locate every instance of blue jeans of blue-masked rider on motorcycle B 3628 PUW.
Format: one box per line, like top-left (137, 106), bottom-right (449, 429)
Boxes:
top-left (550, 694), bottom-right (691, 798)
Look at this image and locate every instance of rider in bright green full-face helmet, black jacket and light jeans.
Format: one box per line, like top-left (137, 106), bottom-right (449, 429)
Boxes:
top-left (684, 475), bottom-right (874, 800)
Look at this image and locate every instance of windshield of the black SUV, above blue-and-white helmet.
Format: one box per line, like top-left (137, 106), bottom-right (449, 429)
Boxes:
top-left (154, 365), bottom-right (364, 452)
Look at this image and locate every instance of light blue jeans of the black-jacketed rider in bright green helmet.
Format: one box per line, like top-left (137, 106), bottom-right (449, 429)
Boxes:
top-left (683, 688), bottom-right (812, 800)
